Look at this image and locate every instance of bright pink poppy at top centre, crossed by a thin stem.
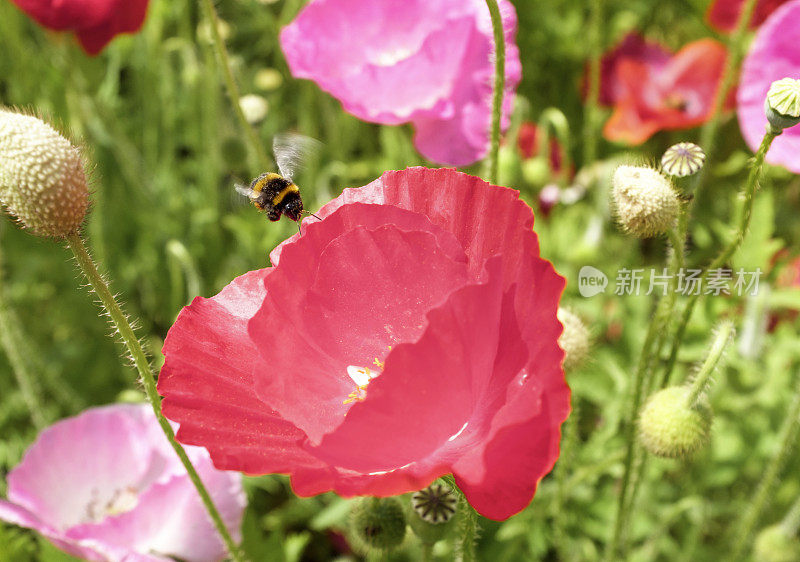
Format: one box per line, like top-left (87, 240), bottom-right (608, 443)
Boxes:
top-left (280, 0), bottom-right (522, 166)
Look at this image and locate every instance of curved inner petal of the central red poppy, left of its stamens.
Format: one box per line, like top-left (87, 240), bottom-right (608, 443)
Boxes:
top-left (249, 204), bottom-right (468, 443)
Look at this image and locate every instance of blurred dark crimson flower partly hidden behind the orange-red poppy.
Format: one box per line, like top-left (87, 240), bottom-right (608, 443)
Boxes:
top-left (584, 31), bottom-right (671, 106)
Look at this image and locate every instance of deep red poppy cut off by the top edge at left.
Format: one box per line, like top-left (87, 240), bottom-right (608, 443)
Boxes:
top-left (12, 0), bottom-right (148, 55)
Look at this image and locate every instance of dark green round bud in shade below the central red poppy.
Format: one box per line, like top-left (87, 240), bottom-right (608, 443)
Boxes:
top-left (350, 498), bottom-right (406, 552)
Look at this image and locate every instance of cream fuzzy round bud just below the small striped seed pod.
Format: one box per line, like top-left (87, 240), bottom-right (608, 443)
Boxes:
top-left (612, 166), bottom-right (680, 238)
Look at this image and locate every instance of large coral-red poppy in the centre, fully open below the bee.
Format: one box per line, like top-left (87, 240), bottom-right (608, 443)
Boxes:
top-left (159, 168), bottom-right (569, 520)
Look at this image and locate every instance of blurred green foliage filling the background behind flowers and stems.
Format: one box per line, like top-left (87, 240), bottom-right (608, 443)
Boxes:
top-left (0, 0), bottom-right (800, 562)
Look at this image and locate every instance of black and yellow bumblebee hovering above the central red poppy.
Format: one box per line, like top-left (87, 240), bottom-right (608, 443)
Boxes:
top-left (236, 134), bottom-right (318, 226)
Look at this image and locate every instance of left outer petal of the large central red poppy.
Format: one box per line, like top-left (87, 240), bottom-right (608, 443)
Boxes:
top-left (158, 269), bottom-right (317, 474)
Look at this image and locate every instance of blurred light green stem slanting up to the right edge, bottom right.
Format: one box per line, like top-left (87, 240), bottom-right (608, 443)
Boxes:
top-left (730, 370), bottom-right (800, 561)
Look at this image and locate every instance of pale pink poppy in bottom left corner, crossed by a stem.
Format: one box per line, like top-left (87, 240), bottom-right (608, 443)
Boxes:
top-left (0, 404), bottom-right (246, 562)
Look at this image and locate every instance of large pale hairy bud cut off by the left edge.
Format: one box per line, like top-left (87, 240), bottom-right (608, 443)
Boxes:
top-left (0, 110), bottom-right (89, 238)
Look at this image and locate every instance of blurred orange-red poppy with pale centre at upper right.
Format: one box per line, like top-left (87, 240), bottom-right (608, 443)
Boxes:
top-left (603, 39), bottom-right (726, 144)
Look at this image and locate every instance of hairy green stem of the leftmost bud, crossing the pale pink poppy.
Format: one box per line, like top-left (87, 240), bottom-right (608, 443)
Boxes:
top-left (66, 234), bottom-right (244, 562)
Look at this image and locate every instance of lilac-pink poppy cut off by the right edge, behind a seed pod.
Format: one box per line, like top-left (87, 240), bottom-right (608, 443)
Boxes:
top-left (736, 0), bottom-right (800, 174)
